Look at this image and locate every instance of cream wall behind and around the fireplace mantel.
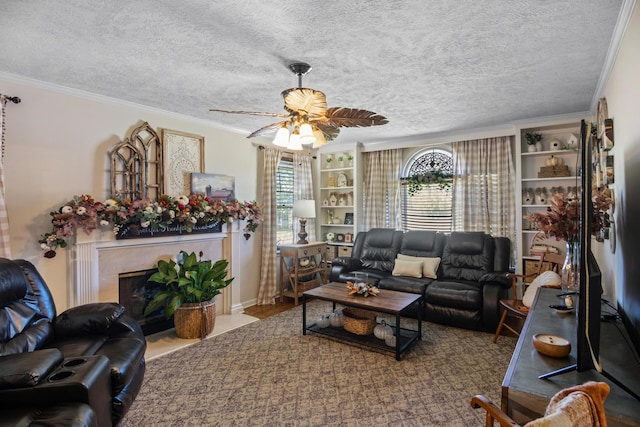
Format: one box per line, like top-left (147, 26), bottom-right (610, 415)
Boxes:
top-left (0, 74), bottom-right (262, 312)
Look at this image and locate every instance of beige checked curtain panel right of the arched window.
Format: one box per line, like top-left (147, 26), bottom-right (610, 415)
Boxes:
top-left (452, 136), bottom-right (516, 244)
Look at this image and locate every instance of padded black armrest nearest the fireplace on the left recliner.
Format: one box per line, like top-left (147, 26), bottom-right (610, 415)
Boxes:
top-left (53, 302), bottom-right (125, 338)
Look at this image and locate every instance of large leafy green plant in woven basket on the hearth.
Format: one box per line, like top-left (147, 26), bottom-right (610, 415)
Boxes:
top-left (144, 251), bottom-right (233, 338)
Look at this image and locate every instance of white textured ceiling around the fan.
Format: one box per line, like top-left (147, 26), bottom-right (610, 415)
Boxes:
top-left (0, 0), bottom-right (623, 143)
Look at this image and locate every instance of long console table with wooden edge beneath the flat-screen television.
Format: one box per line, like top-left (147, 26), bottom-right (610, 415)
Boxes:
top-left (501, 288), bottom-right (640, 427)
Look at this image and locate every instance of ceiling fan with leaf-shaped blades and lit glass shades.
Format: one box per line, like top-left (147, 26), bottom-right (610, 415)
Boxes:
top-left (209, 62), bottom-right (388, 150)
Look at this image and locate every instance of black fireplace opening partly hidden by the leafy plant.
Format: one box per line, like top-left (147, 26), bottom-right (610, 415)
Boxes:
top-left (118, 268), bottom-right (173, 335)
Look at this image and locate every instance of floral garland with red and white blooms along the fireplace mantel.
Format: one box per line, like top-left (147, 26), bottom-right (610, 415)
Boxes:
top-left (38, 194), bottom-right (264, 258)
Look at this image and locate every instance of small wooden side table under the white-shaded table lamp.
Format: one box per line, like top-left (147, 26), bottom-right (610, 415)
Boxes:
top-left (280, 242), bottom-right (327, 305)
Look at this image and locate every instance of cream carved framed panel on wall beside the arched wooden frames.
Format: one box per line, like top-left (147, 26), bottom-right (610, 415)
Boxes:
top-left (162, 129), bottom-right (204, 197)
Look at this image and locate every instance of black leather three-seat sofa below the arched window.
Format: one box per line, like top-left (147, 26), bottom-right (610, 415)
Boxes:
top-left (330, 228), bottom-right (511, 332)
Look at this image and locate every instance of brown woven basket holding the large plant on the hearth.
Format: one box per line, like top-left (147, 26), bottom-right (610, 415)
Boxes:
top-left (173, 298), bottom-right (216, 339)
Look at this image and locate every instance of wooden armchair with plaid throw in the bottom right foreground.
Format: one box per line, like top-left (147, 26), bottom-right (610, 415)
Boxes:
top-left (471, 381), bottom-right (611, 427)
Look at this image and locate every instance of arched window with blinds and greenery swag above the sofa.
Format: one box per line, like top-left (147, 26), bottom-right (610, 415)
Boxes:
top-left (402, 148), bottom-right (453, 232)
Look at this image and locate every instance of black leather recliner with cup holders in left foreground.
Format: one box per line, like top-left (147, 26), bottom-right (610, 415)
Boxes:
top-left (0, 258), bottom-right (146, 426)
